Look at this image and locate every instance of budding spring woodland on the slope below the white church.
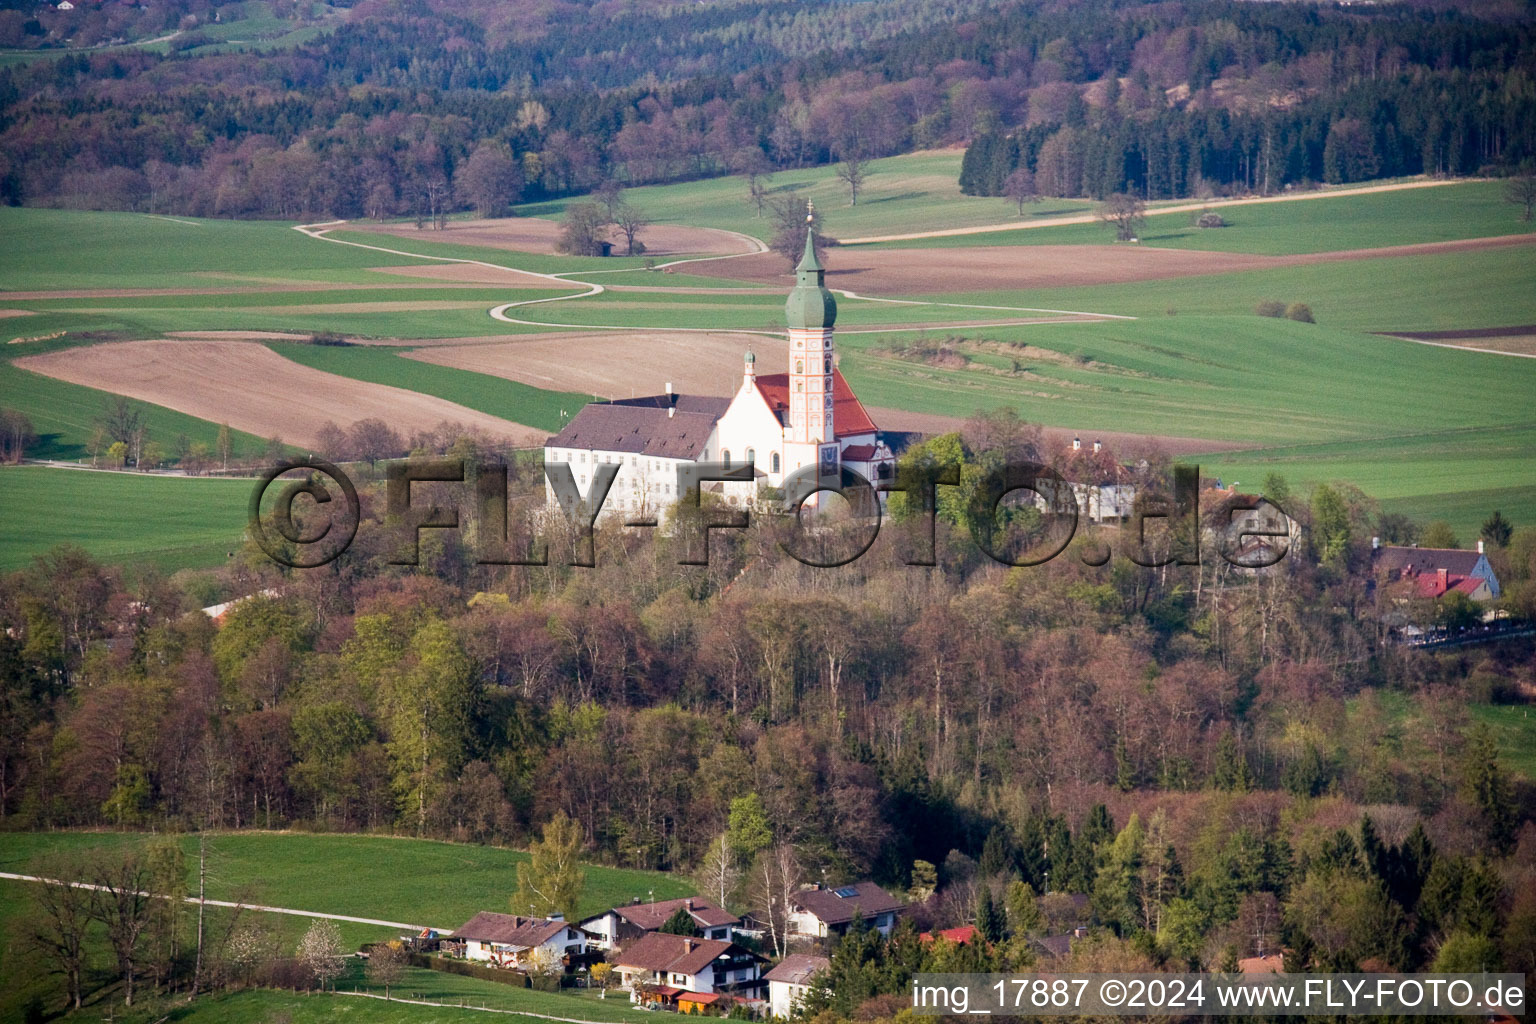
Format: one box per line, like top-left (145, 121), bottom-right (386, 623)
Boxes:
top-left (0, 418), bottom-right (1536, 982)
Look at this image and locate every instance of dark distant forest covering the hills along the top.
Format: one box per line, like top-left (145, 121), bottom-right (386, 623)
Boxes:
top-left (0, 0), bottom-right (1536, 218)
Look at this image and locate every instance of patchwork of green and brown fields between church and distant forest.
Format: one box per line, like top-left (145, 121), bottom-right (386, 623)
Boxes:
top-left (0, 171), bottom-right (1536, 560)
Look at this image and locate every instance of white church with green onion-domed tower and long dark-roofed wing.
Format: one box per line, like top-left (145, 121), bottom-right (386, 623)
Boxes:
top-left (544, 230), bottom-right (897, 519)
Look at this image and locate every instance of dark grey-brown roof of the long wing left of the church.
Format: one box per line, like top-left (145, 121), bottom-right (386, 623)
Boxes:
top-left (544, 395), bottom-right (731, 459)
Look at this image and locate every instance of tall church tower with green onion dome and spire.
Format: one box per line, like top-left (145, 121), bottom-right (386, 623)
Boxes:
top-left (785, 216), bottom-right (837, 476)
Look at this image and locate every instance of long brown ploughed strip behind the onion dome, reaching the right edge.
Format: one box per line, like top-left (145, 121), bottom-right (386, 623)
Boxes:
top-left (688, 235), bottom-right (1536, 295)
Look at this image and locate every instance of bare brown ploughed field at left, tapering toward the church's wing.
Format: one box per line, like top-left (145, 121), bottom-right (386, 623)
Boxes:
top-left (15, 341), bottom-right (548, 445)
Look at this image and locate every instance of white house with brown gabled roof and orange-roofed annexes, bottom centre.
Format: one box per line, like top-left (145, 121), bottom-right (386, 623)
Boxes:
top-left (611, 932), bottom-right (763, 1006)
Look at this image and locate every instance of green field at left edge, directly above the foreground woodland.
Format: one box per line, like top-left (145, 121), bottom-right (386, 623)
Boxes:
top-left (0, 467), bottom-right (253, 574)
